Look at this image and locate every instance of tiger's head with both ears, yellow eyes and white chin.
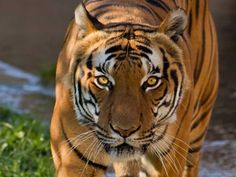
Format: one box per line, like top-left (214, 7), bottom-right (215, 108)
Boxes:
top-left (70, 5), bottom-right (187, 159)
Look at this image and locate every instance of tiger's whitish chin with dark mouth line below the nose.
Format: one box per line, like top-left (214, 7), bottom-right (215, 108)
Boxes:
top-left (104, 143), bottom-right (147, 162)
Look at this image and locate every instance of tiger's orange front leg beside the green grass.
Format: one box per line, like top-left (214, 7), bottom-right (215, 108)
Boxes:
top-left (51, 103), bottom-right (109, 177)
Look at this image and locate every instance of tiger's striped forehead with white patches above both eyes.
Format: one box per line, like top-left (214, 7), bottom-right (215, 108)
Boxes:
top-left (92, 31), bottom-right (163, 73)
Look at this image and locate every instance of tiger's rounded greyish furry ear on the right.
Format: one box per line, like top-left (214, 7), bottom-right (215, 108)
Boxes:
top-left (159, 9), bottom-right (188, 39)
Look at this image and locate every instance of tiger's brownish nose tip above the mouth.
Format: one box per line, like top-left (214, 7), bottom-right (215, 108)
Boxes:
top-left (110, 124), bottom-right (141, 138)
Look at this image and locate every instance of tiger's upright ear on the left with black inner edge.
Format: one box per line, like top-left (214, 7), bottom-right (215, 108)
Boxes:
top-left (75, 3), bottom-right (103, 37)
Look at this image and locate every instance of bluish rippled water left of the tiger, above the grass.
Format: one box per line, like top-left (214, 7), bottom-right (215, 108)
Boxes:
top-left (0, 60), bottom-right (54, 120)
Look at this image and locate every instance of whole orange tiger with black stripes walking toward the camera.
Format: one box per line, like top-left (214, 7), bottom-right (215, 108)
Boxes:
top-left (50, 0), bottom-right (219, 177)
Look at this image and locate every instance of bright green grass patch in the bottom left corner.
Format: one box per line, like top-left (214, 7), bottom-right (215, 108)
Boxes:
top-left (0, 107), bottom-right (54, 177)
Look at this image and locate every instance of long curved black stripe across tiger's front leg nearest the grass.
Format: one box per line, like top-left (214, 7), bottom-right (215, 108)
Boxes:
top-left (61, 122), bottom-right (108, 171)
